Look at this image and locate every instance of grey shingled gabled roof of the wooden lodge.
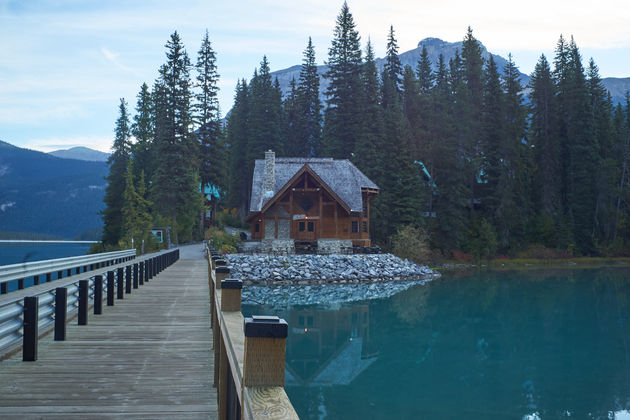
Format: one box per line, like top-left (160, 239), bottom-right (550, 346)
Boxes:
top-left (249, 158), bottom-right (378, 212)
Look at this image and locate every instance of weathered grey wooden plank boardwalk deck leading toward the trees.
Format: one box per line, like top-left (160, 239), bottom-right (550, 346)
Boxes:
top-left (0, 253), bottom-right (217, 419)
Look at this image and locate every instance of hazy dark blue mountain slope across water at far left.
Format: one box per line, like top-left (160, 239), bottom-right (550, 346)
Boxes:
top-left (0, 141), bottom-right (108, 239)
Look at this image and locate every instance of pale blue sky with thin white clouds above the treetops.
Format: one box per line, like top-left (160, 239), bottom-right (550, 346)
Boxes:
top-left (0, 0), bottom-right (630, 151)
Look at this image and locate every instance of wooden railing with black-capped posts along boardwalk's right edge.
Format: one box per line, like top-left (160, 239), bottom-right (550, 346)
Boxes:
top-left (206, 244), bottom-right (298, 420)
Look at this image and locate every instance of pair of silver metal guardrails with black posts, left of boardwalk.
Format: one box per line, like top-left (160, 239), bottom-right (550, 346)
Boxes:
top-left (0, 250), bottom-right (179, 361)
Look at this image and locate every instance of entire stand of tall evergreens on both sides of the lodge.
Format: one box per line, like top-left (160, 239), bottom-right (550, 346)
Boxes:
top-left (102, 3), bottom-right (630, 259)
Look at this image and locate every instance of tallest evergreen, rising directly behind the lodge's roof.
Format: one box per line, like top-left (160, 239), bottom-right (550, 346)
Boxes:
top-left (323, 2), bottom-right (364, 159)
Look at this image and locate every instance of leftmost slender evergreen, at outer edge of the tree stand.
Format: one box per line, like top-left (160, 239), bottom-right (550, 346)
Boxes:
top-left (101, 98), bottom-right (131, 246)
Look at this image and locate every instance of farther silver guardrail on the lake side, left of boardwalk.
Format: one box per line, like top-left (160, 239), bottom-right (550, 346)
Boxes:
top-left (0, 249), bottom-right (136, 295)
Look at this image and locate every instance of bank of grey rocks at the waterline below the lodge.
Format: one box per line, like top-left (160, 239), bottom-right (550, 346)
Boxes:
top-left (227, 254), bottom-right (439, 285)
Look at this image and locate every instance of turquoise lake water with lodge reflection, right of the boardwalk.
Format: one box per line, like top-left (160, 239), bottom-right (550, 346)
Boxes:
top-left (243, 268), bottom-right (630, 420)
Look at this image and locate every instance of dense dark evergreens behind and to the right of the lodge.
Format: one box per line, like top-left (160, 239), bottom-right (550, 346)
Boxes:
top-left (227, 5), bottom-right (630, 257)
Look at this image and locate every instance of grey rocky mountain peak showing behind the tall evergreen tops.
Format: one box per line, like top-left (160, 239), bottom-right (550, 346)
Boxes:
top-left (271, 38), bottom-right (630, 104)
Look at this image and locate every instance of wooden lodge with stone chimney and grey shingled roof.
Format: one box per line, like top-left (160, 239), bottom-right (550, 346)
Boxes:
top-left (246, 150), bottom-right (379, 252)
